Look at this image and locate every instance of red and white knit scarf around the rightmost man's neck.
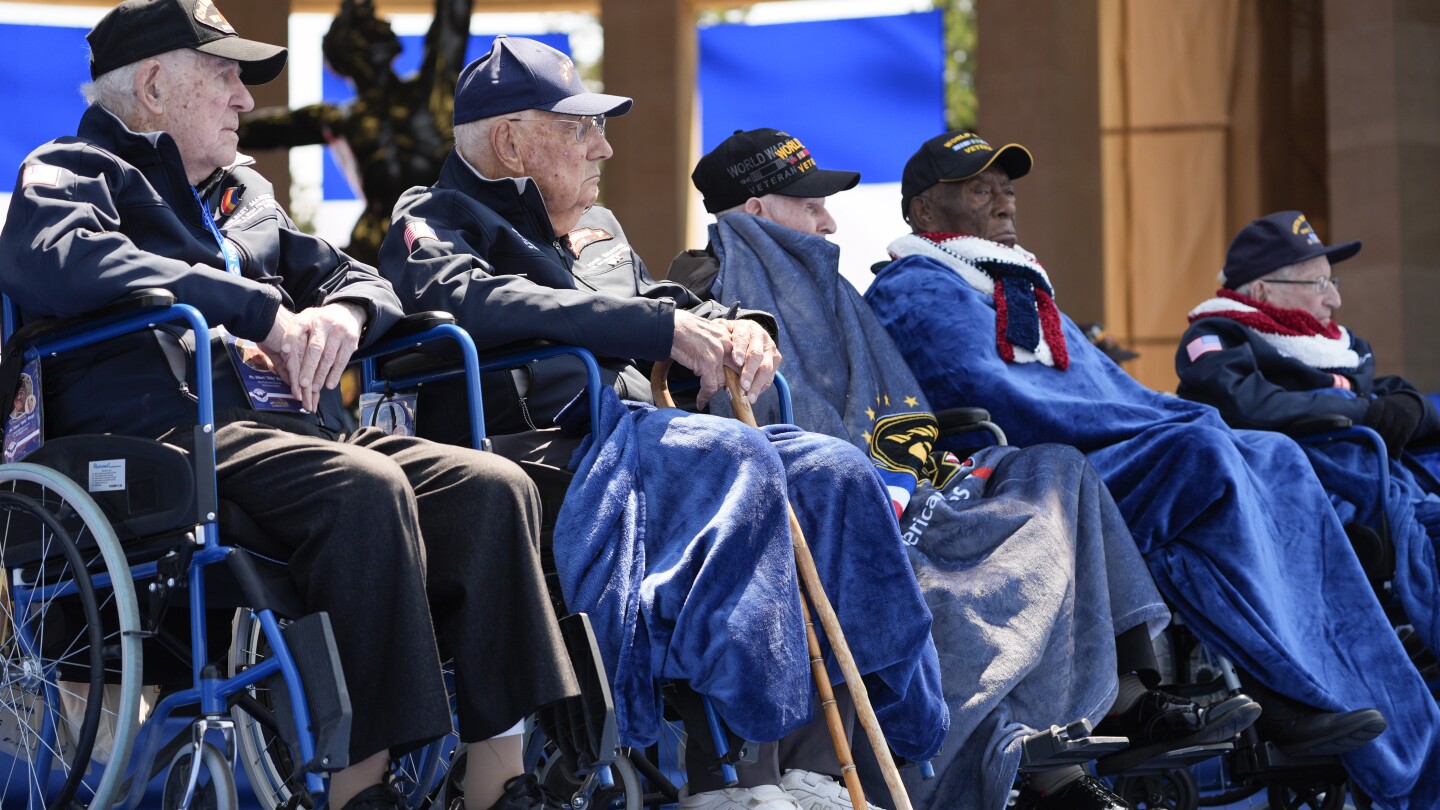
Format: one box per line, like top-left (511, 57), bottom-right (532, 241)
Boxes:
top-left (1189, 290), bottom-right (1361, 369)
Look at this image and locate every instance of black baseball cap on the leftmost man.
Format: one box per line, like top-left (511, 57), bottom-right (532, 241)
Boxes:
top-left (85, 0), bottom-right (287, 85)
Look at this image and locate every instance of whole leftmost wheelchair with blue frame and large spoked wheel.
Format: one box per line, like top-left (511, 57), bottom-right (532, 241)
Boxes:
top-left (0, 290), bottom-right (489, 810)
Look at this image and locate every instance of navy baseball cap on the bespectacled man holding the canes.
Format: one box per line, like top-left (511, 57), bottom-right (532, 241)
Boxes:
top-left (455, 36), bottom-right (632, 124)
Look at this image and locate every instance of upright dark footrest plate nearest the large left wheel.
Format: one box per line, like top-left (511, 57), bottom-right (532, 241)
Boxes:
top-left (269, 613), bottom-right (350, 773)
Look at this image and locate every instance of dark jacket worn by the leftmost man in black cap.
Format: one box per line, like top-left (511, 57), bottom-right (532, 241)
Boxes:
top-left (0, 107), bottom-right (400, 437)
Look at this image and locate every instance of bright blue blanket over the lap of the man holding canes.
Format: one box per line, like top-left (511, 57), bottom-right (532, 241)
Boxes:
top-left (554, 391), bottom-right (949, 758)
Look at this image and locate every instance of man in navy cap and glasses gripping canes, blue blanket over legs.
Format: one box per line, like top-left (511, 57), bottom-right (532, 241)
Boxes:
top-left (380, 37), bottom-right (948, 810)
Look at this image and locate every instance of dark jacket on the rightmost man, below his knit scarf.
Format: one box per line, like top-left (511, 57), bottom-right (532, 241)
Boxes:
top-left (1175, 317), bottom-right (1440, 435)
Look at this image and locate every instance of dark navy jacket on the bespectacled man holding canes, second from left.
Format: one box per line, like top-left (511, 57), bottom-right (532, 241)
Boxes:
top-left (380, 151), bottom-right (773, 441)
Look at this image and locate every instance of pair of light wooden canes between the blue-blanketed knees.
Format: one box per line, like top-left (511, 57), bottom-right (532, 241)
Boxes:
top-left (649, 360), bottom-right (912, 810)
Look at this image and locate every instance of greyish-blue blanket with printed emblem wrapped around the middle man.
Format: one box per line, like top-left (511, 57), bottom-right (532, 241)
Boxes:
top-left (710, 215), bottom-right (1169, 810)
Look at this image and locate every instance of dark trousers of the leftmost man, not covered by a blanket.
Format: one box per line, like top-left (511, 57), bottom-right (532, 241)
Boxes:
top-left (194, 411), bottom-right (576, 762)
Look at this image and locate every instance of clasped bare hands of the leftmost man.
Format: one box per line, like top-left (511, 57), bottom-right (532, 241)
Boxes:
top-left (259, 301), bottom-right (366, 412)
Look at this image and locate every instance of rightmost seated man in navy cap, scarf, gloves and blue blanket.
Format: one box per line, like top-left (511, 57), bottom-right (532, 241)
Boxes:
top-left (1175, 210), bottom-right (1440, 677)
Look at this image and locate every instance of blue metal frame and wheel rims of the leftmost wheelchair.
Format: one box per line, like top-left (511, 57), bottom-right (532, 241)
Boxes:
top-left (0, 291), bottom-right (482, 809)
